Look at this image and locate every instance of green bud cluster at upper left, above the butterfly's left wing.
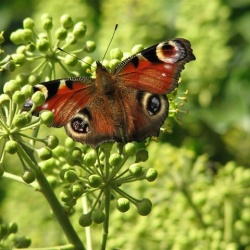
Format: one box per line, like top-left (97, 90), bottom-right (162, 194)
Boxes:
top-left (0, 14), bottom-right (96, 79)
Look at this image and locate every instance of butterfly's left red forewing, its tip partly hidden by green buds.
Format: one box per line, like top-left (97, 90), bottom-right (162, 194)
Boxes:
top-left (34, 78), bottom-right (95, 127)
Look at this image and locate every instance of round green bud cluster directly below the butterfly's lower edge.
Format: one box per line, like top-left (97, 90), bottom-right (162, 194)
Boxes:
top-left (53, 139), bottom-right (157, 226)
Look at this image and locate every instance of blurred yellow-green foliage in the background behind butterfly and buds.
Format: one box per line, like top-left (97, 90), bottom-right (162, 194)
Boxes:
top-left (0, 0), bottom-right (250, 249)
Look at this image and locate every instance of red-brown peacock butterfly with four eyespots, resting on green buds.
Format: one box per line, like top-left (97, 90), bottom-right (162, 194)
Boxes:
top-left (25, 38), bottom-right (195, 148)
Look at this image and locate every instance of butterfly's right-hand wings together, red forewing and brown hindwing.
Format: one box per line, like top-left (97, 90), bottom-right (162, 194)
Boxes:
top-left (108, 38), bottom-right (195, 141)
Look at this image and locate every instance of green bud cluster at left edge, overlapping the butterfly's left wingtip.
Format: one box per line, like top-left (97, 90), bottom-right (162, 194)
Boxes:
top-left (0, 80), bottom-right (58, 178)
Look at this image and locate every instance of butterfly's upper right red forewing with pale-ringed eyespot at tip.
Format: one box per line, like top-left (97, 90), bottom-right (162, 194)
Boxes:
top-left (114, 38), bottom-right (195, 94)
